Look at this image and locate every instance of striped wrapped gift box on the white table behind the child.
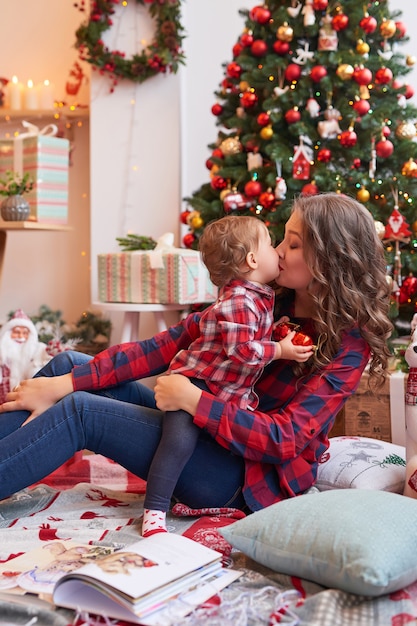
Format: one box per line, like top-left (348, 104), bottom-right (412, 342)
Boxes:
top-left (98, 248), bottom-right (217, 304)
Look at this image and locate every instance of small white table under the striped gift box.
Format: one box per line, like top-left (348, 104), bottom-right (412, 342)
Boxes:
top-left (93, 302), bottom-right (188, 343)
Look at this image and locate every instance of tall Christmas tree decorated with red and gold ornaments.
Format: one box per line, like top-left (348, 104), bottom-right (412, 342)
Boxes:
top-left (181, 0), bottom-right (417, 332)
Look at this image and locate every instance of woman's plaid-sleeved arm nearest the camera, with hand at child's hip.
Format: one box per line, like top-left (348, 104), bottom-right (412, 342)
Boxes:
top-left (156, 330), bottom-right (369, 464)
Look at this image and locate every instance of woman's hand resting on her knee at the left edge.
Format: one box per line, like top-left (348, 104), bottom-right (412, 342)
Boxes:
top-left (0, 373), bottom-right (74, 426)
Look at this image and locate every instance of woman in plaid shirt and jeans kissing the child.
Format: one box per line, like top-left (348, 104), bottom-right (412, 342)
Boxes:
top-left (0, 194), bottom-right (391, 511)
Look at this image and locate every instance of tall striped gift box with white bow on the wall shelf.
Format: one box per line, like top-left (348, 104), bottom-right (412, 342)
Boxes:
top-left (0, 121), bottom-right (69, 224)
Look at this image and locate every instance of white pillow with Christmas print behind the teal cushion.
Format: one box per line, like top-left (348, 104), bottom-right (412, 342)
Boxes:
top-left (315, 437), bottom-right (405, 493)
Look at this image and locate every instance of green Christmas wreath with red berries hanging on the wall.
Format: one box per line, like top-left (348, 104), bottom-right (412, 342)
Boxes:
top-left (75, 0), bottom-right (184, 91)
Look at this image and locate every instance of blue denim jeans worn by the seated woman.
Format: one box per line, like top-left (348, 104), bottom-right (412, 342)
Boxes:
top-left (0, 351), bottom-right (245, 508)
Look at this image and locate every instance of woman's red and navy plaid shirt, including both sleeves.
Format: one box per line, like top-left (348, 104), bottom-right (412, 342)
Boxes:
top-left (73, 304), bottom-right (370, 511)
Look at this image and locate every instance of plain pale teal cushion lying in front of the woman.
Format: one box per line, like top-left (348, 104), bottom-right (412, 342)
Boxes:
top-left (219, 489), bottom-right (417, 596)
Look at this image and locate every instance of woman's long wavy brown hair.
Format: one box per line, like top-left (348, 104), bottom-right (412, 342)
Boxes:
top-left (277, 193), bottom-right (392, 388)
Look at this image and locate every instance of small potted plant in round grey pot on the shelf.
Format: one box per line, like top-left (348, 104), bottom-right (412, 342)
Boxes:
top-left (0, 170), bottom-right (33, 222)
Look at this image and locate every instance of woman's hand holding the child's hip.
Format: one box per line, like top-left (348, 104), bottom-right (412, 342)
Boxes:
top-left (154, 374), bottom-right (202, 415)
